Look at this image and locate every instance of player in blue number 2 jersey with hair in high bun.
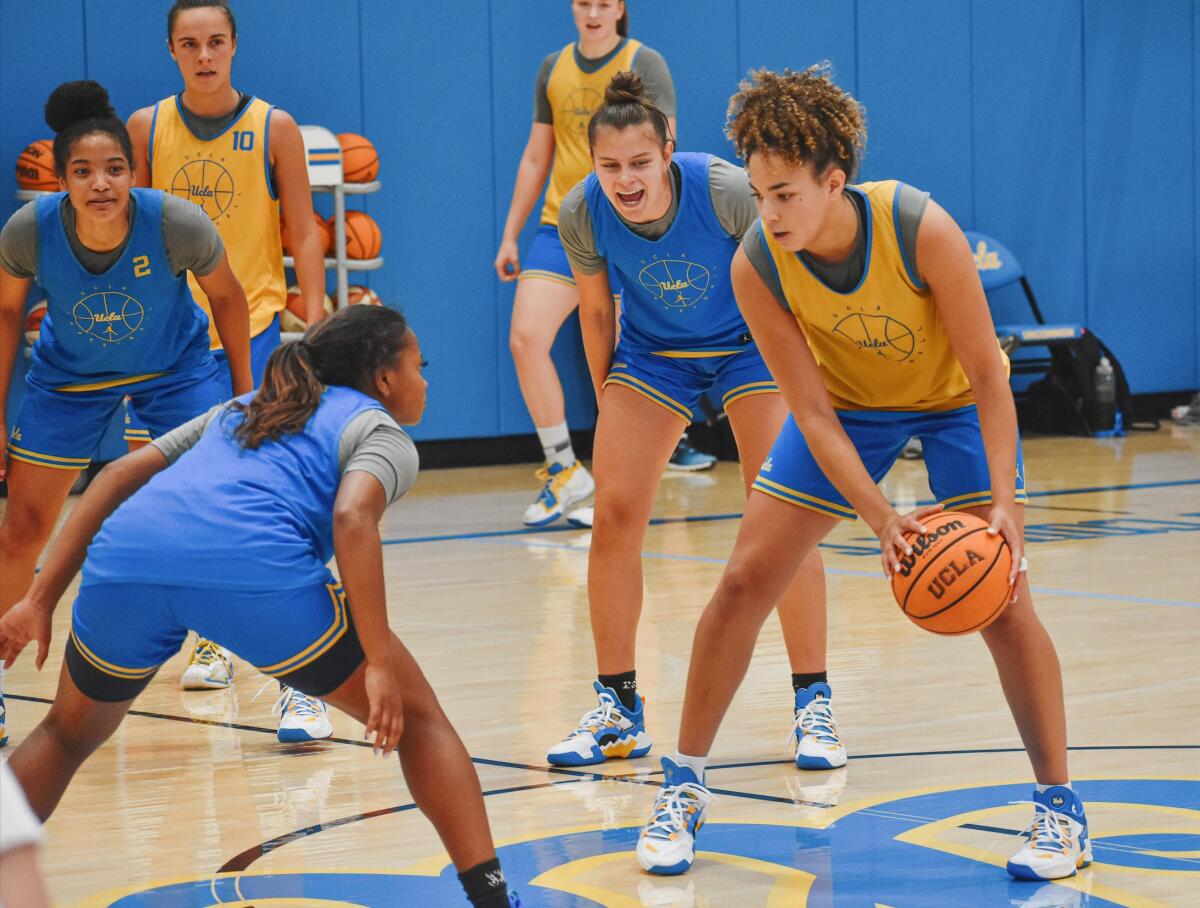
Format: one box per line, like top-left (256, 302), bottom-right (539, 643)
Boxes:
top-left (0, 82), bottom-right (251, 744)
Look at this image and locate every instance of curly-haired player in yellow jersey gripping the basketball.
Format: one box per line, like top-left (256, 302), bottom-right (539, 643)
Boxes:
top-left (637, 67), bottom-right (1091, 879)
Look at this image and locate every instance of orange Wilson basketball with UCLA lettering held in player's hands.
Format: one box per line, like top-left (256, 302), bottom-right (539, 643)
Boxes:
top-left (892, 511), bottom-right (1013, 635)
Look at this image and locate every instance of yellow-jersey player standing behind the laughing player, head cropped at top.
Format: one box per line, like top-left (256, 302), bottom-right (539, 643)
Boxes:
top-left (494, 0), bottom-right (700, 527)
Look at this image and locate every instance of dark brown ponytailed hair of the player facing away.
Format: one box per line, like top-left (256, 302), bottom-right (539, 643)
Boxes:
top-left (229, 306), bottom-right (409, 449)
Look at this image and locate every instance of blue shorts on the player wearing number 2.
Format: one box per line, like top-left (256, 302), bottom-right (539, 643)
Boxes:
top-left (8, 356), bottom-right (224, 470)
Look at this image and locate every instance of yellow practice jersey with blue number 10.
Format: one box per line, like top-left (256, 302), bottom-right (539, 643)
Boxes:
top-left (150, 95), bottom-right (287, 349)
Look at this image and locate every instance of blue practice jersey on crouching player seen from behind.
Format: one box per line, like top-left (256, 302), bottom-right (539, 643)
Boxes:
top-left (83, 383), bottom-right (383, 591)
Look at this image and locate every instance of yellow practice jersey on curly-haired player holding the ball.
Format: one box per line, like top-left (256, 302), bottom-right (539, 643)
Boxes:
top-left (762, 180), bottom-right (1007, 410)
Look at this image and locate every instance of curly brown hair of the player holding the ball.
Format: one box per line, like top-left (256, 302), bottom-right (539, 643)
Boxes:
top-left (725, 62), bottom-right (866, 180)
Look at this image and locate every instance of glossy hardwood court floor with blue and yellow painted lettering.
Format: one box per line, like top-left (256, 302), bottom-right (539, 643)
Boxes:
top-left (0, 427), bottom-right (1200, 908)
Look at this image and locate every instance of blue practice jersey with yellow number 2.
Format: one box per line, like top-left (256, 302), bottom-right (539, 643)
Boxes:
top-left (30, 190), bottom-right (209, 391)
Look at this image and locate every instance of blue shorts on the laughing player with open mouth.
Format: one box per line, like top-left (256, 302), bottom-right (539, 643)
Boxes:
top-left (604, 342), bottom-right (779, 425)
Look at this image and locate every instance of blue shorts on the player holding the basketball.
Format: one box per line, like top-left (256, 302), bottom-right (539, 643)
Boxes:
top-left (754, 404), bottom-right (1028, 521)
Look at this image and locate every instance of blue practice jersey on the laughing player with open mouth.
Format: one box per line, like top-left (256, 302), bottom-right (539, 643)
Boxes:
top-left (583, 152), bottom-right (748, 356)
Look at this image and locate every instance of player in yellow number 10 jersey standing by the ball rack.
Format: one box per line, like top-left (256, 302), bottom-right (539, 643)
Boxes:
top-left (125, 0), bottom-right (332, 740)
